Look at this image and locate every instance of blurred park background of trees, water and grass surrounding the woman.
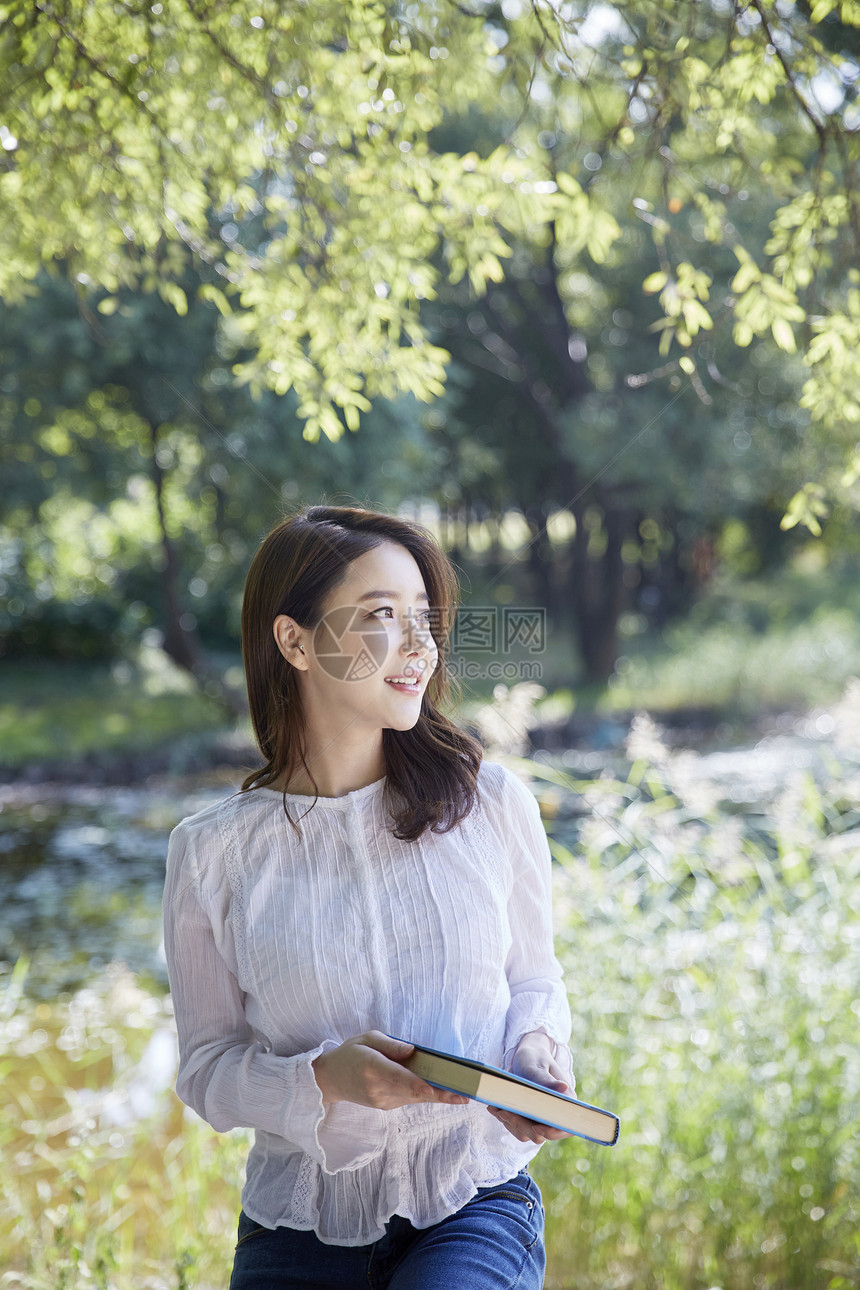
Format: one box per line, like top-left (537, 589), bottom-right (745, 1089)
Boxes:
top-left (0, 0), bottom-right (860, 1290)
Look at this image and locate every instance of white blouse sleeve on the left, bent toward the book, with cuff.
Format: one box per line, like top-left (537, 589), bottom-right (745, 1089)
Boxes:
top-left (164, 823), bottom-right (384, 1174)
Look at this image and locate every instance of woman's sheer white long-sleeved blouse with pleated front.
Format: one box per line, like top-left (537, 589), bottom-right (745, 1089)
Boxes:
top-left (164, 761), bottom-right (574, 1245)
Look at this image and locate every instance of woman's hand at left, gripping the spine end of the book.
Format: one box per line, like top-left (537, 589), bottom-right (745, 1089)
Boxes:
top-left (311, 1031), bottom-right (469, 1111)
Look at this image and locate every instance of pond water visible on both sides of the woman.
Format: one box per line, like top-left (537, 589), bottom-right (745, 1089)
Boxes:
top-left (0, 721), bottom-right (845, 1000)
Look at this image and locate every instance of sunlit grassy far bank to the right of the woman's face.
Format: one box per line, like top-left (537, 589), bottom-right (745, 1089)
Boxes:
top-left (440, 559), bottom-right (860, 722)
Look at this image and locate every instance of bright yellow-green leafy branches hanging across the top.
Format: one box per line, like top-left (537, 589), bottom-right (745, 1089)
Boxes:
top-left (0, 0), bottom-right (860, 516)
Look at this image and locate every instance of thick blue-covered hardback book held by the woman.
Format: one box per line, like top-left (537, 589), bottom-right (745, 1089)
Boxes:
top-left (389, 1035), bottom-right (620, 1147)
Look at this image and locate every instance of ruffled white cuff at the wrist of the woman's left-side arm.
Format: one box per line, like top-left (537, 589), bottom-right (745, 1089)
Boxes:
top-left (293, 1040), bottom-right (387, 1174)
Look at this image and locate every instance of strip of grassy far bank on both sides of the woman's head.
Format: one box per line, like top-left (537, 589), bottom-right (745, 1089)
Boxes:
top-left (0, 566), bottom-right (860, 769)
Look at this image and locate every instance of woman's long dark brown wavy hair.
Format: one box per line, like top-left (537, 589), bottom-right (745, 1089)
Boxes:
top-left (242, 506), bottom-right (482, 841)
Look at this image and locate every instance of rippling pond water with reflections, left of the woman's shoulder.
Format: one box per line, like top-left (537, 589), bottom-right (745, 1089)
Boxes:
top-left (0, 774), bottom-right (236, 1000)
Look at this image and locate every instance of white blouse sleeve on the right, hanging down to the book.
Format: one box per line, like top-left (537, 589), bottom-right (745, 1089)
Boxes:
top-left (503, 770), bottom-right (575, 1093)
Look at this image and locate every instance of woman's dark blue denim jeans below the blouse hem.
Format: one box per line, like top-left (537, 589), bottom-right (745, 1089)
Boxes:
top-left (230, 1169), bottom-right (547, 1290)
